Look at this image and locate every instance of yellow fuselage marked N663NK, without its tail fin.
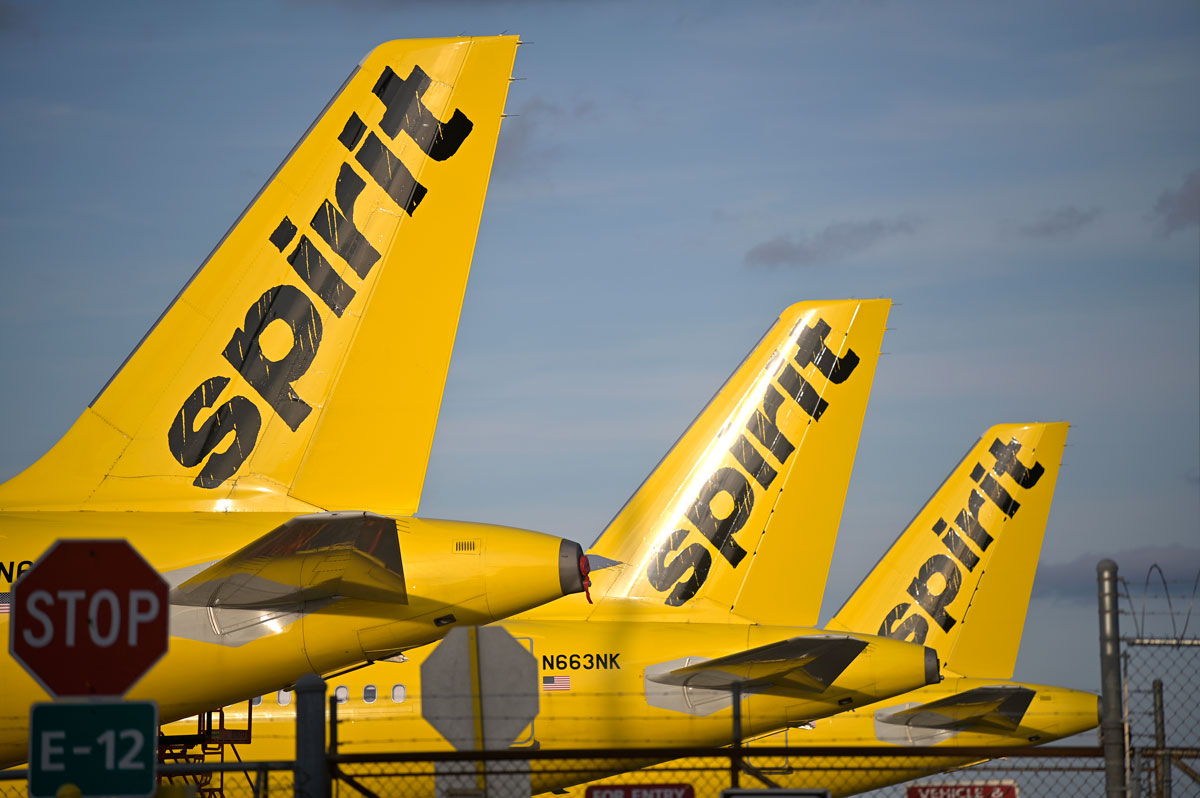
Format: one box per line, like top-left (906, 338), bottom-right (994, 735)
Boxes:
top-left (162, 620), bottom-right (925, 792)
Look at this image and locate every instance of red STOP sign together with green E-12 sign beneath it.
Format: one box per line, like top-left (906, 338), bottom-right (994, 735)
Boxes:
top-left (8, 540), bottom-right (168, 798)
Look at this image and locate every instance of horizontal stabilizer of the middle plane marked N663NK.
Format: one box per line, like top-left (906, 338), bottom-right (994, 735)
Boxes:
top-left (647, 635), bottom-right (866, 695)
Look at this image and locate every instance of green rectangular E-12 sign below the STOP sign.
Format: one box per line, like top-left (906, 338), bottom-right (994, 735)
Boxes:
top-left (29, 701), bottom-right (158, 798)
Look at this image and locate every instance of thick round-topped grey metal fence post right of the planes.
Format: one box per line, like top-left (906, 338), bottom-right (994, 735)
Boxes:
top-left (1096, 559), bottom-right (1127, 798)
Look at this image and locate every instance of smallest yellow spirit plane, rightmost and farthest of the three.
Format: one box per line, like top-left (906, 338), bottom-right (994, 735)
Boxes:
top-left (580, 424), bottom-right (1099, 796)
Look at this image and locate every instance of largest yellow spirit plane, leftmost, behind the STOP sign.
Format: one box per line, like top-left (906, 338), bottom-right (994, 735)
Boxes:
top-left (0, 36), bottom-right (584, 766)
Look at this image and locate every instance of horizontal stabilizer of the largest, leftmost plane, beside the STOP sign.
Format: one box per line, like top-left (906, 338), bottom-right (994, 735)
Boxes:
top-left (170, 512), bottom-right (408, 610)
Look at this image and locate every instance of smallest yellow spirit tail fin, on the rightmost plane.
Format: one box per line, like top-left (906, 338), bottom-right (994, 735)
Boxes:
top-left (828, 422), bottom-right (1068, 679)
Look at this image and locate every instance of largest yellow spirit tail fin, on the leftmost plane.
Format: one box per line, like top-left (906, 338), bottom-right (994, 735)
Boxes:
top-left (0, 36), bottom-right (517, 515)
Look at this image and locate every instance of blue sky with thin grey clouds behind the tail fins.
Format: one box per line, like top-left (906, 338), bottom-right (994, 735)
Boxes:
top-left (0, 0), bottom-right (1200, 689)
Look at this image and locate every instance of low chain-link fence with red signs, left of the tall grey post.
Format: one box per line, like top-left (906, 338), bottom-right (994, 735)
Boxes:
top-left (0, 748), bottom-right (1104, 798)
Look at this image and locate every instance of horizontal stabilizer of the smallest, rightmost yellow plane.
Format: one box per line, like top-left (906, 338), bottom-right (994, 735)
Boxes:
top-left (876, 685), bottom-right (1034, 733)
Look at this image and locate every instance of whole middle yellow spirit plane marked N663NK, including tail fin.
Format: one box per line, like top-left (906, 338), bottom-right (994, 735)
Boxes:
top-left (162, 300), bottom-right (940, 792)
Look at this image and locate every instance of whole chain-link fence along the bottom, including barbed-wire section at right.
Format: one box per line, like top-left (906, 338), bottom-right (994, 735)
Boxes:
top-left (7, 559), bottom-right (1200, 798)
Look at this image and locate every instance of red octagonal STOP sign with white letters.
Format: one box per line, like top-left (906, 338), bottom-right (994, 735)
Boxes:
top-left (8, 540), bottom-right (167, 696)
